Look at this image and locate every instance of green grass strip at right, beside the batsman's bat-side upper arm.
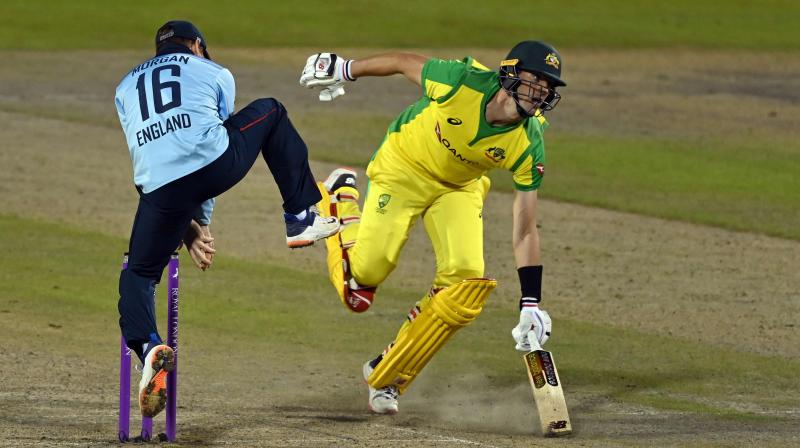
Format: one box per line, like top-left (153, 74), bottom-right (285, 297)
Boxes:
top-left (506, 135), bottom-right (800, 239)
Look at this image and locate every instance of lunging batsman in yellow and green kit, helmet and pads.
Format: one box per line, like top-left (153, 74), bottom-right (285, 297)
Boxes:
top-left (300, 41), bottom-right (566, 414)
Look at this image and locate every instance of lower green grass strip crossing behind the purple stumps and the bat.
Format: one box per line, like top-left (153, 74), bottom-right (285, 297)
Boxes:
top-left (0, 215), bottom-right (800, 420)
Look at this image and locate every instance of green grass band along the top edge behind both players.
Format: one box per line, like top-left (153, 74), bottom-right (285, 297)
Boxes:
top-left (0, 0), bottom-right (800, 50)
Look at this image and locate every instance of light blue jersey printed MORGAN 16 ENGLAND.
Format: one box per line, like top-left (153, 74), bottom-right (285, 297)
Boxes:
top-left (115, 52), bottom-right (236, 224)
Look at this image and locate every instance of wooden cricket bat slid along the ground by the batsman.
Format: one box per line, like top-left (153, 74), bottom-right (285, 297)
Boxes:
top-left (522, 332), bottom-right (572, 437)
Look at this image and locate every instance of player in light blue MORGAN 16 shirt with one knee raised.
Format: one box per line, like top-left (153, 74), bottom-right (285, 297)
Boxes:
top-left (115, 21), bottom-right (339, 417)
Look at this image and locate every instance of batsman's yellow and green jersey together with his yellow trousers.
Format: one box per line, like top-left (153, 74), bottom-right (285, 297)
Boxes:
top-left (331, 58), bottom-right (547, 288)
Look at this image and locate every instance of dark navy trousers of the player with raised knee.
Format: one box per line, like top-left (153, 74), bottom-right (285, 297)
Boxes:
top-left (118, 98), bottom-right (322, 359)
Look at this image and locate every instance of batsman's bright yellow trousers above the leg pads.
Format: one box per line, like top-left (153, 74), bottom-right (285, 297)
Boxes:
top-left (342, 173), bottom-right (490, 288)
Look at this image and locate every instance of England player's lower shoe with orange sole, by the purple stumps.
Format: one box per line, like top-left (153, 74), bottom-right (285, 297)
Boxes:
top-left (139, 344), bottom-right (175, 417)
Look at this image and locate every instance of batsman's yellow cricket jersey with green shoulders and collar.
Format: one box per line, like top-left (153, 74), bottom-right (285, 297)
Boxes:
top-left (367, 57), bottom-right (547, 191)
